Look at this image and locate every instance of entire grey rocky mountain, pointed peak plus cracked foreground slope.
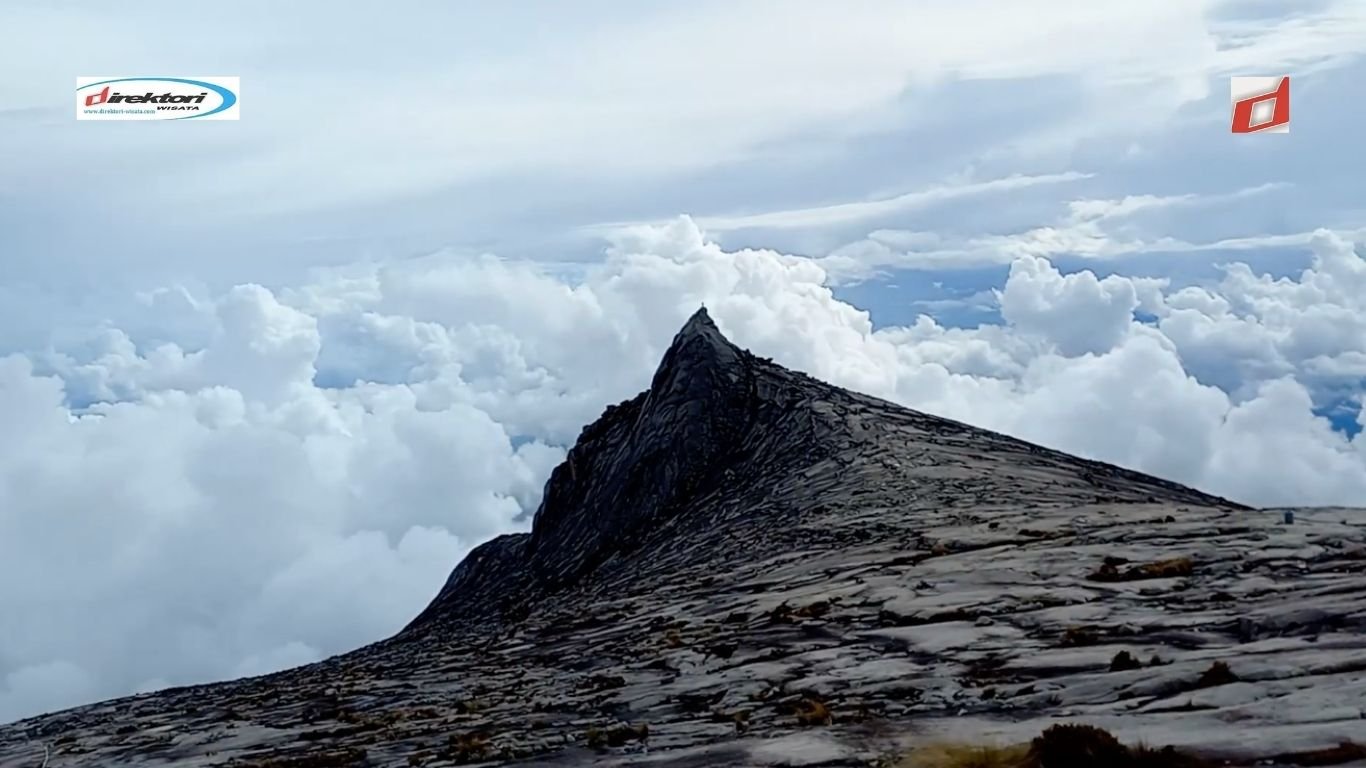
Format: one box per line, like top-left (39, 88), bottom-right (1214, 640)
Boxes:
top-left (0, 310), bottom-right (1366, 768)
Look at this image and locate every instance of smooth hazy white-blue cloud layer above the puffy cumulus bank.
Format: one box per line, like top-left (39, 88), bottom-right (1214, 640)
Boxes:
top-left (0, 0), bottom-right (1366, 332)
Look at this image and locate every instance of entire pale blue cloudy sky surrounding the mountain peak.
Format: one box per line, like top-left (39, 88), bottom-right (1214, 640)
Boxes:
top-left (0, 0), bottom-right (1366, 722)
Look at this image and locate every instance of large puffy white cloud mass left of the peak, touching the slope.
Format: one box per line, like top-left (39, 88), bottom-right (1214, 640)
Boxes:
top-left (0, 286), bottom-right (561, 719)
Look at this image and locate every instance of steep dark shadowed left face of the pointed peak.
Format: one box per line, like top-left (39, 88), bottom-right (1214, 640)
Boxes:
top-left (410, 310), bottom-right (770, 630)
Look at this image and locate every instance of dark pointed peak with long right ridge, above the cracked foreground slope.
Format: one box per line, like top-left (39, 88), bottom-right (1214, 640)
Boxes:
top-left (410, 307), bottom-right (1225, 629)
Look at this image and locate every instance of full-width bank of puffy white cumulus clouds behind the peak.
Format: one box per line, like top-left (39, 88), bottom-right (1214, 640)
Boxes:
top-left (0, 219), bottom-right (1366, 719)
